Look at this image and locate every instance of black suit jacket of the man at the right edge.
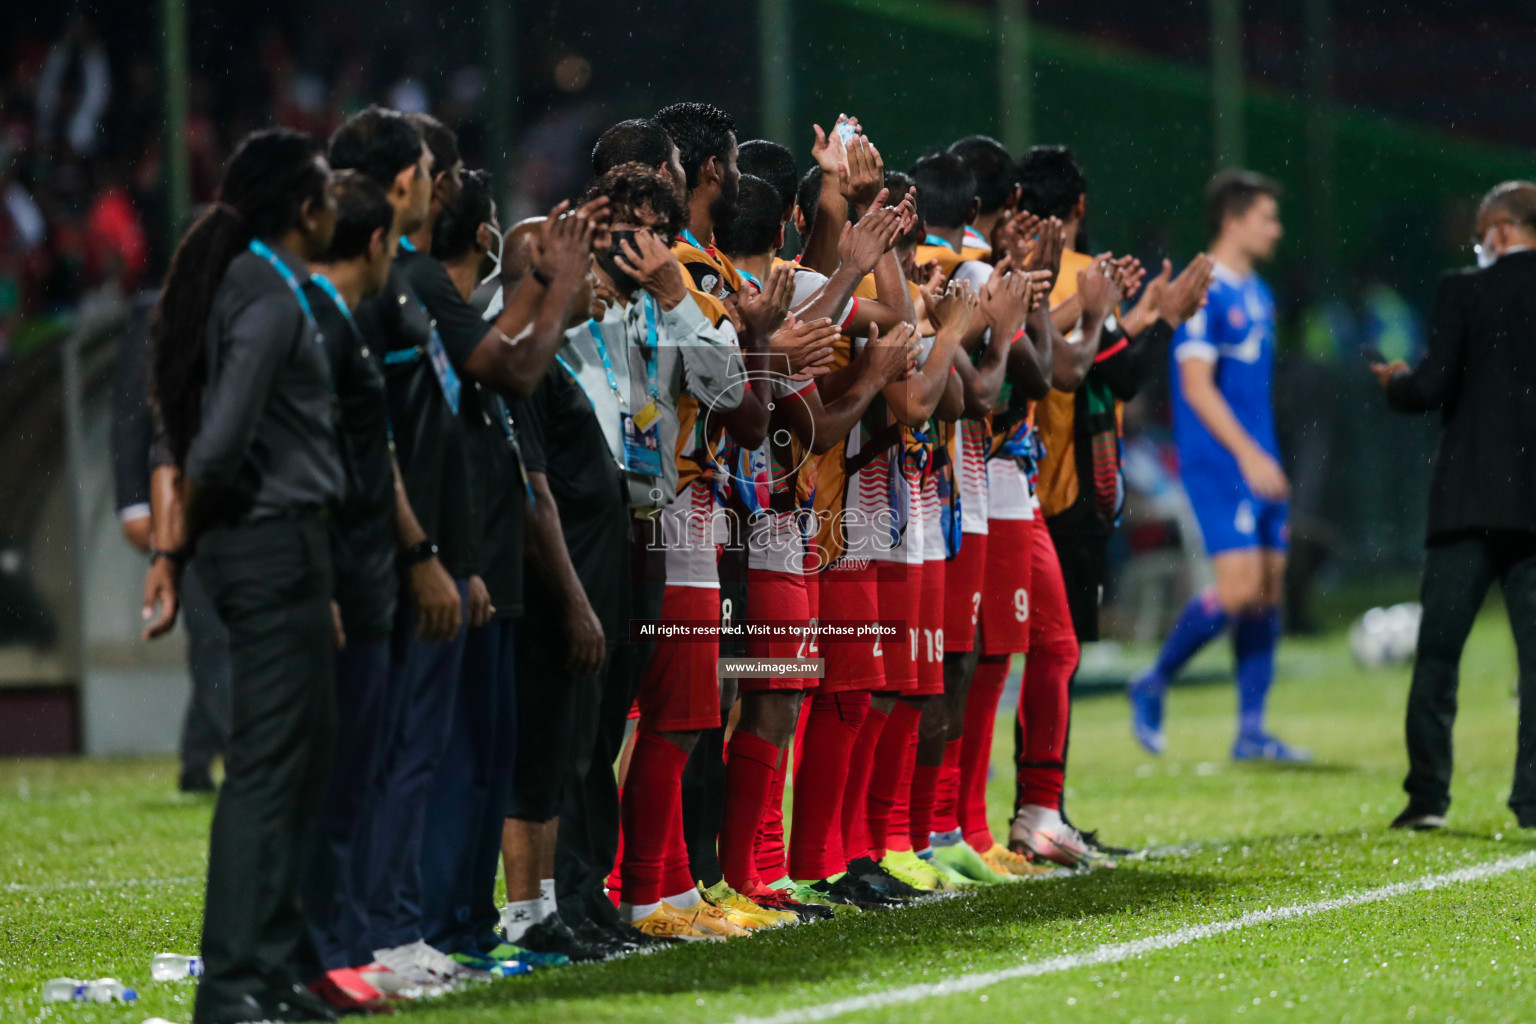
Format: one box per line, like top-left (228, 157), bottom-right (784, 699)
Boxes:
top-left (1387, 252), bottom-right (1536, 539)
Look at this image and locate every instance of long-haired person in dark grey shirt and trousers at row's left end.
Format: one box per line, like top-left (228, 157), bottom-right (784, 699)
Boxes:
top-left (144, 129), bottom-right (344, 1024)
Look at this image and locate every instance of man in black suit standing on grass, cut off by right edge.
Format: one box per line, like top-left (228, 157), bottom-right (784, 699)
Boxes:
top-left (1372, 181), bottom-right (1536, 829)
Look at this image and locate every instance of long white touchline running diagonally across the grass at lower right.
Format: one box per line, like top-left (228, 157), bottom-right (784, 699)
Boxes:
top-left (731, 852), bottom-right (1536, 1024)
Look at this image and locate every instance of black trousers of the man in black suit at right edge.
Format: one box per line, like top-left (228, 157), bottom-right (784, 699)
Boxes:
top-left (1402, 531), bottom-right (1536, 827)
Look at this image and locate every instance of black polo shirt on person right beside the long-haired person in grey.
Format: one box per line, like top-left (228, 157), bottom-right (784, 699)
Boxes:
top-left (304, 274), bottom-right (399, 640)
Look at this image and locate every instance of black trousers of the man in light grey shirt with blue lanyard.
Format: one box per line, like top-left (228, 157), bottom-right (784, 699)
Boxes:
top-left (554, 524), bottom-right (667, 924)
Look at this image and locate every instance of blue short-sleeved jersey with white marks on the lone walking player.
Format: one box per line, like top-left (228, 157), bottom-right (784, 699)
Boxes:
top-left (1170, 264), bottom-right (1279, 477)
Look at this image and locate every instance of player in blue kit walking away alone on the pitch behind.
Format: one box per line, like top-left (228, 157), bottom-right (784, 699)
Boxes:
top-left (1130, 170), bottom-right (1312, 761)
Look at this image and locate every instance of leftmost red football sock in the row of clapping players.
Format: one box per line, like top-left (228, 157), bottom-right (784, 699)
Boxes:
top-left (621, 729), bottom-right (688, 904)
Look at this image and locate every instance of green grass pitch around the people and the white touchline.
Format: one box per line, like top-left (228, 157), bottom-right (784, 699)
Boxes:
top-left (0, 616), bottom-right (1536, 1024)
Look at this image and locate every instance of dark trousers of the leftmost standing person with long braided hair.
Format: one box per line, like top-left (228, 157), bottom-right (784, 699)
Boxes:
top-left (194, 517), bottom-right (335, 1021)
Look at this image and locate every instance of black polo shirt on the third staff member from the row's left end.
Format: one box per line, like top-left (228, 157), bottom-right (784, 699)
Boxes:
top-left (356, 249), bottom-right (479, 579)
